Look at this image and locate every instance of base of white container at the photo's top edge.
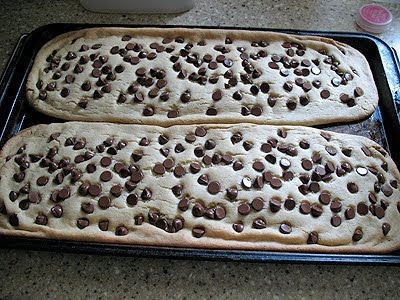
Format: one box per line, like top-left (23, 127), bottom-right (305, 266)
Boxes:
top-left (80, 0), bottom-right (194, 14)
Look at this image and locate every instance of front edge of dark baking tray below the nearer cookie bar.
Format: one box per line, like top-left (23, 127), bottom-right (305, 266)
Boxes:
top-left (0, 236), bottom-right (400, 266)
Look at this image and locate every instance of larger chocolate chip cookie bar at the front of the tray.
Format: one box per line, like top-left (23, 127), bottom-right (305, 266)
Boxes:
top-left (0, 122), bottom-right (400, 253)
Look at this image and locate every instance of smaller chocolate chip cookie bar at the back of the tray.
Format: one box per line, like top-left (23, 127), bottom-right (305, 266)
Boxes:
top-left (27, 28), bottom-right (378, 126)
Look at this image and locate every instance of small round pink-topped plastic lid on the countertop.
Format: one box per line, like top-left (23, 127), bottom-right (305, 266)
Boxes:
top-left (356, 4), bottom-right (392, 33)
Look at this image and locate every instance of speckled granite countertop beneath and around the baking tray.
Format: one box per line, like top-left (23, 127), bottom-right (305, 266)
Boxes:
top-left (0, 0), bottom-right (400, 299)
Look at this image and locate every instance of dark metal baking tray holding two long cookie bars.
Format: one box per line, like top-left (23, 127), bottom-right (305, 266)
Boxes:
top-left (0, 24), bottom-right (400, 265)
